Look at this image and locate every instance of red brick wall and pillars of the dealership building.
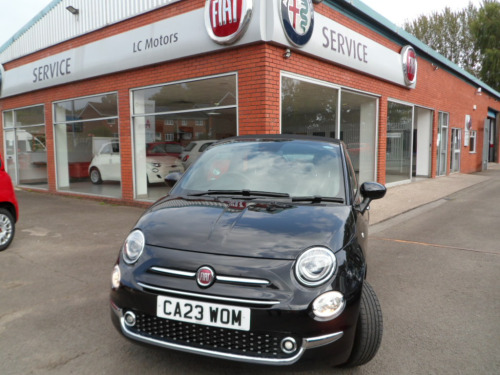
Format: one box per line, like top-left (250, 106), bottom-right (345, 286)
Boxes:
top-left (0, 0), bottom-right (500, 202)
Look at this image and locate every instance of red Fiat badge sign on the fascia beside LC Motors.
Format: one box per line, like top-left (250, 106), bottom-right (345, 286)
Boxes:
top-left (205, 0), bottom-right (253, 44)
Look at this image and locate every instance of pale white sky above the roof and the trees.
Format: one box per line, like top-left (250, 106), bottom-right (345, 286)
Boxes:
top-left (0, 0), bottom-right (488, 46)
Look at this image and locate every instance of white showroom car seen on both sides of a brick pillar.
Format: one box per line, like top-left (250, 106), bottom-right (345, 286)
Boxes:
top-left (89, 141), bottom-right (184, 184)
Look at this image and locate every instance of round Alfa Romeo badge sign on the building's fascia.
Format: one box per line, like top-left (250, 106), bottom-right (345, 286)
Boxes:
top-left (279, 0), bottom-right (314, 47)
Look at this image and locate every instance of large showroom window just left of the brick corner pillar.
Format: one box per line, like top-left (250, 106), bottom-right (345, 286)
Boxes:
top-left (132, 74), bottom-right (238, 200)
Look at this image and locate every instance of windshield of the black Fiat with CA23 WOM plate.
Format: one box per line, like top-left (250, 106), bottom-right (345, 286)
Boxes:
top-left (171, 140), bottom-right (345, 199)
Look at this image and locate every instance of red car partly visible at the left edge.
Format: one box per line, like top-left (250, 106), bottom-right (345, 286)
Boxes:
top-left (0, 157), bottom-right (19, 251)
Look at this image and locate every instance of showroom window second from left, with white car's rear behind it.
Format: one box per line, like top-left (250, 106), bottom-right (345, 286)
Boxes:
top-left (54, 93), bottom-right (121, 198)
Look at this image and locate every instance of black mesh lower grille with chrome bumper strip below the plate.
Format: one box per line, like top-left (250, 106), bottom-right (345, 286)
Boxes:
top-left (111, 302), bottom-right (344, 365)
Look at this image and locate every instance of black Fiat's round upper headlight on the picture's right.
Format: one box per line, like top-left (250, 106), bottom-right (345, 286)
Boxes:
top-left (295, 247), bottom-right (337, 286)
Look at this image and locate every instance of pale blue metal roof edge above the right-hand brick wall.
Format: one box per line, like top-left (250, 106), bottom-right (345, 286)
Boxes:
top-left (325, 0), bottom-right (500, 99)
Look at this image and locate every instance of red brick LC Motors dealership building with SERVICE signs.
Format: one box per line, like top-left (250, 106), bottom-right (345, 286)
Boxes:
top-left (0, 0), bottom-right (500, 204)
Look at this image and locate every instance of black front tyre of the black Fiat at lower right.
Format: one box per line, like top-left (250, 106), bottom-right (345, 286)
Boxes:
top-left (344, 280), bottom-right (383, 367)
